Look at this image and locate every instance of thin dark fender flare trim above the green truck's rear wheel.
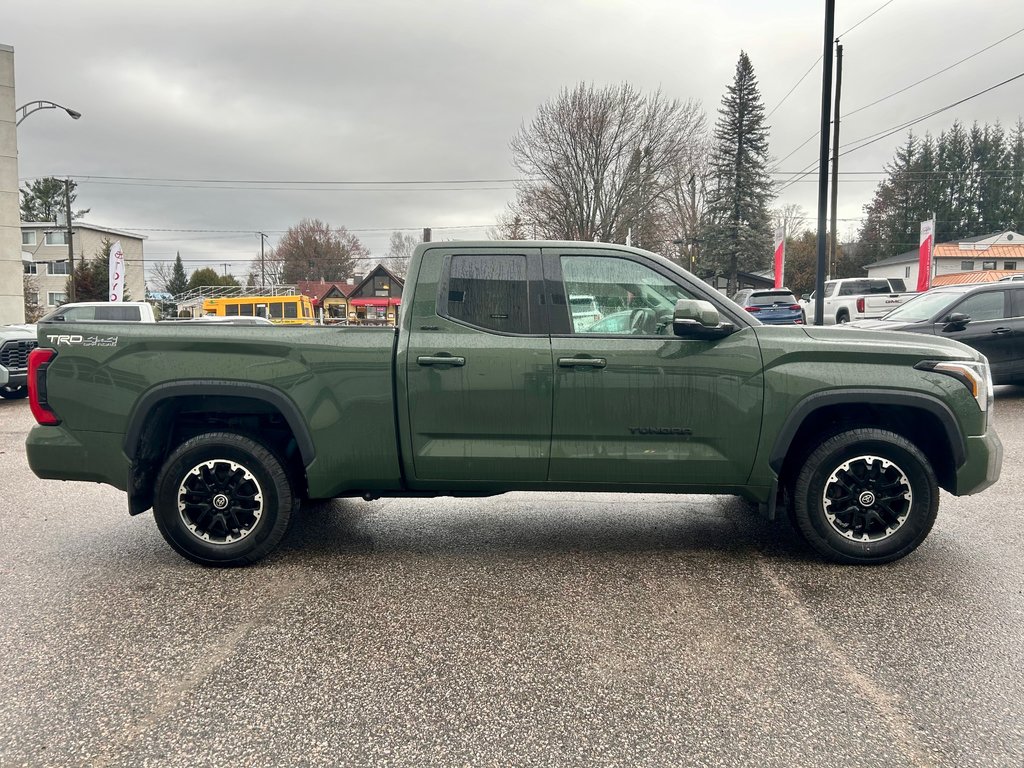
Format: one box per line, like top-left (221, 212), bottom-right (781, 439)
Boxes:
top-left (124, 379), bottom-right (316, 467)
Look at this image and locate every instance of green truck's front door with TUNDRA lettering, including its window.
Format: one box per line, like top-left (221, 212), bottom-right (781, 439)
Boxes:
top-left (544, 248), bottom-right (763, 486)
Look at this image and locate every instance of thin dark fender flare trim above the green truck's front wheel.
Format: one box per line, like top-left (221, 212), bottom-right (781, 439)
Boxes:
top-left (768, 389), bottom-right (967, 475)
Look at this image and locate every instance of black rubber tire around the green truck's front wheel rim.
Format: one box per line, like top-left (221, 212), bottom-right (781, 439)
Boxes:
top-left (795, 430), bottom-right (938, 563)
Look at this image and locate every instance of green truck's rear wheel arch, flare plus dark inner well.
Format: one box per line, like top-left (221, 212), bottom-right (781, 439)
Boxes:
top-left (124, 380), bottom-right (316, 514)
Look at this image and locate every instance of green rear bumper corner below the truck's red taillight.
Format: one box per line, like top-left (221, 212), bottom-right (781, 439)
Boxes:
top-left (25, 424), bottom-right (128, 490)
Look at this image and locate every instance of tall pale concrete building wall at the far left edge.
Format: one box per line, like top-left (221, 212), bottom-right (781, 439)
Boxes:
top-left (0, 45), bottom-right (25, 326)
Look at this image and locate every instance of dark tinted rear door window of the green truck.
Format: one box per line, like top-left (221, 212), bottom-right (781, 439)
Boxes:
top-left (442, 254), bottom-right (529, 334)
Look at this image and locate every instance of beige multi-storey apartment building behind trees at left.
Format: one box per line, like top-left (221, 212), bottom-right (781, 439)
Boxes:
top-left (22, 221), bottom-right (145, 310)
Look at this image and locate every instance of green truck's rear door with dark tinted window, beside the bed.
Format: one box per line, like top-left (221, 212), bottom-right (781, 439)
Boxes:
top-left (401, 248), bottom-right (551, 489)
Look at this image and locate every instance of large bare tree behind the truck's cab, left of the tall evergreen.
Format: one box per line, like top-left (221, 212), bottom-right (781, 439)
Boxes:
top-left (510, 83), bottom-right (706, 246)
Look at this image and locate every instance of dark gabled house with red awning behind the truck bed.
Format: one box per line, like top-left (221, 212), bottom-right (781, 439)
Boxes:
top-left (296, 264), bottom-right (404, 326)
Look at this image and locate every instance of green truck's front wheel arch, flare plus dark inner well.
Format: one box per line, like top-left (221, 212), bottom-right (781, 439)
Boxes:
top-left (768, 389), bottom-right (967, 490)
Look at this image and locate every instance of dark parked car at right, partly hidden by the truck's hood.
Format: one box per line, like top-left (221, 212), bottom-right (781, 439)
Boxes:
top-left (847, 282), bottom-right (1024, 384)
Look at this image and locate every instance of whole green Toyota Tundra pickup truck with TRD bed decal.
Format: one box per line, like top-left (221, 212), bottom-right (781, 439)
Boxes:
top-left (28, 242), bottom-right (1002, 565)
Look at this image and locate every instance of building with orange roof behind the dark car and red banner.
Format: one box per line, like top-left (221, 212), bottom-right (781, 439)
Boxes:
top-left (864, 229), bottom-right (1024, 288)
